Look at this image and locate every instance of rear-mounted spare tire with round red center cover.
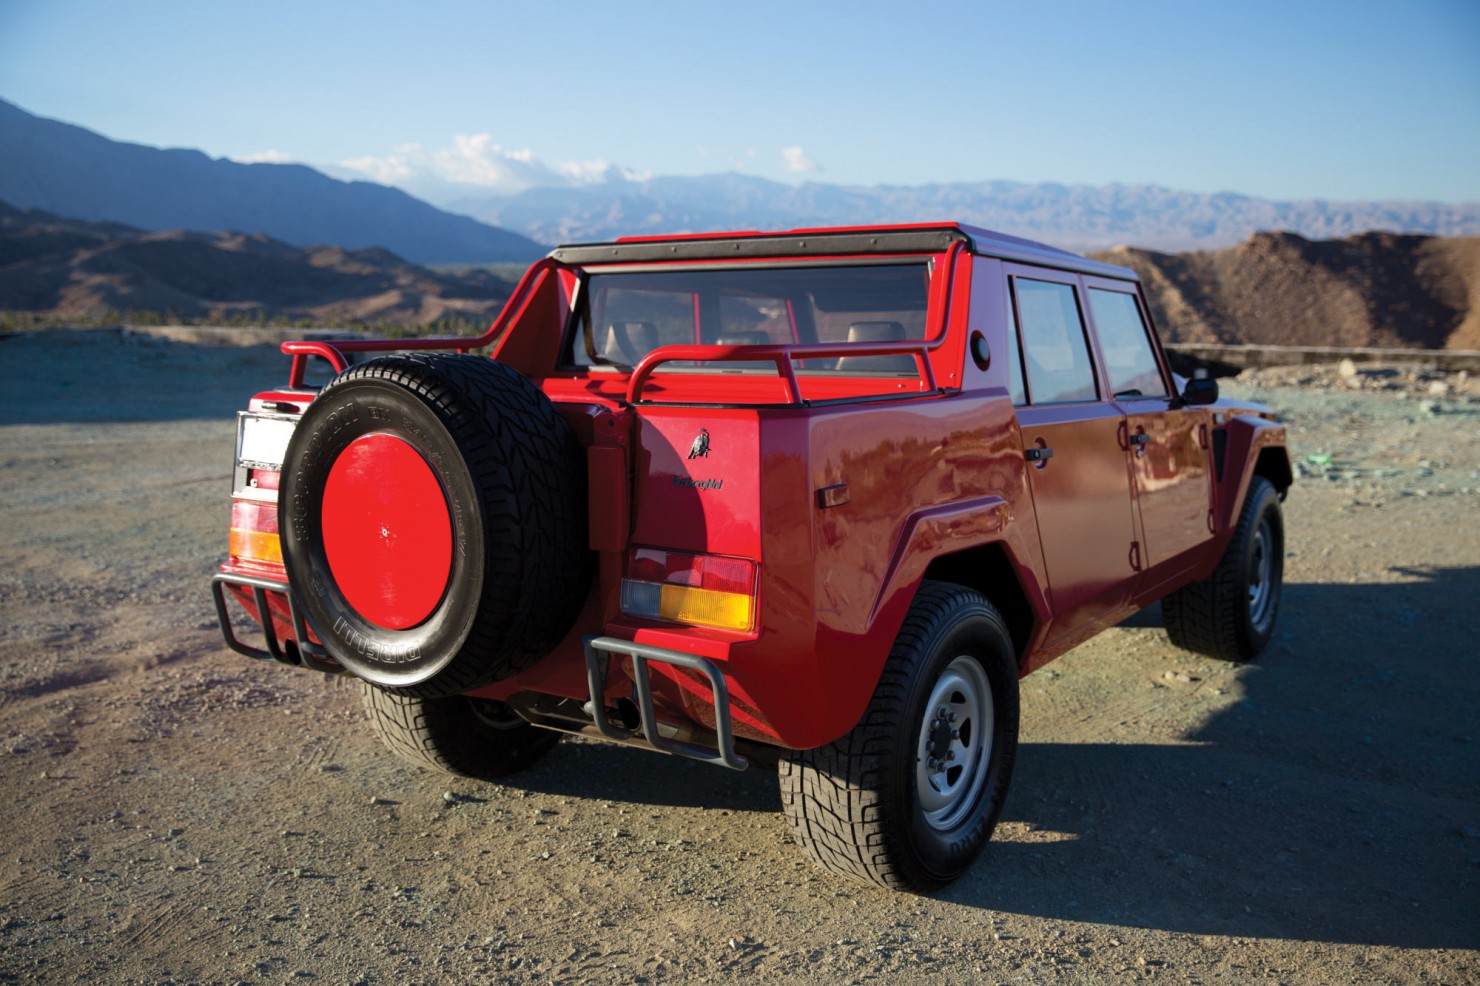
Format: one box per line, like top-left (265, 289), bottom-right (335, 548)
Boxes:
top-left (278, 354), bottom-right (591, 697)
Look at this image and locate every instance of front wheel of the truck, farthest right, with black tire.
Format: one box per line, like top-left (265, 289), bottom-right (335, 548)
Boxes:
top-left (1162, 475), bottom-right (1285, 660)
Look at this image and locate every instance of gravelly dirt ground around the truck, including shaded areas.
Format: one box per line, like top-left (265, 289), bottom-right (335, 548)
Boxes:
top-left (0, 333), bottom-right (1480, 983)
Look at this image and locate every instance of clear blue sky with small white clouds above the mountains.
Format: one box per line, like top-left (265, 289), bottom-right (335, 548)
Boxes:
top-left (0, 0), bottom-right (1480, 201)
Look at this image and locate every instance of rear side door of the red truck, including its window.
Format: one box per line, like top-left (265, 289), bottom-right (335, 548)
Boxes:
top-left (1005, 265), bottom-right (1141, 638)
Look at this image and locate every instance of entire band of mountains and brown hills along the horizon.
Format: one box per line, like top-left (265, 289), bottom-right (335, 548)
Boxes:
top-left (0, 101), bottom-right (1480, 348)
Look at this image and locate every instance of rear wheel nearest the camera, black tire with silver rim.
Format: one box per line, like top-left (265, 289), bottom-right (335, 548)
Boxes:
top-left (778, 582), bottom-right (1018, 893)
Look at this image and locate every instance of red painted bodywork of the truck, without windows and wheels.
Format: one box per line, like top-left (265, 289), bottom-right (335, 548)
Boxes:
top-left (214, 225), bottom-right (1288, 748)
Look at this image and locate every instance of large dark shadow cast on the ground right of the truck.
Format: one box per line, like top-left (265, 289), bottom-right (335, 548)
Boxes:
top-left (941, 569), bottom-right (1480, 949)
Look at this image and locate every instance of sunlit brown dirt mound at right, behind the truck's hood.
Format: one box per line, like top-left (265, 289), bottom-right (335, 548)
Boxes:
top-left (1097, 232), bottom-right (1480, 349)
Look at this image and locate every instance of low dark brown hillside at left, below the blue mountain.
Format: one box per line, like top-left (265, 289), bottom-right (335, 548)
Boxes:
top-left (0, 203), bottom-right (511, 324)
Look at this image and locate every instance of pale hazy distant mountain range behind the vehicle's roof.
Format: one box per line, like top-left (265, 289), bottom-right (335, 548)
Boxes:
top-left (447, 175), bottom-right (1480, 252)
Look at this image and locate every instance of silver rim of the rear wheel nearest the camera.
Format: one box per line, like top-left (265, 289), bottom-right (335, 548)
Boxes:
top-left (915, 656), bottom-right (996, 832)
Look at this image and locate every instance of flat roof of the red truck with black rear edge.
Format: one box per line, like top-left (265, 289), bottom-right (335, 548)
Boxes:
top-left (549, 222), bottom-right (1138, 281)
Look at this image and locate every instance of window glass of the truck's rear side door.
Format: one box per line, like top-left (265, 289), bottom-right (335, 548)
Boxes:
top-left (1012, 277), bottom-right (1097, 404)
